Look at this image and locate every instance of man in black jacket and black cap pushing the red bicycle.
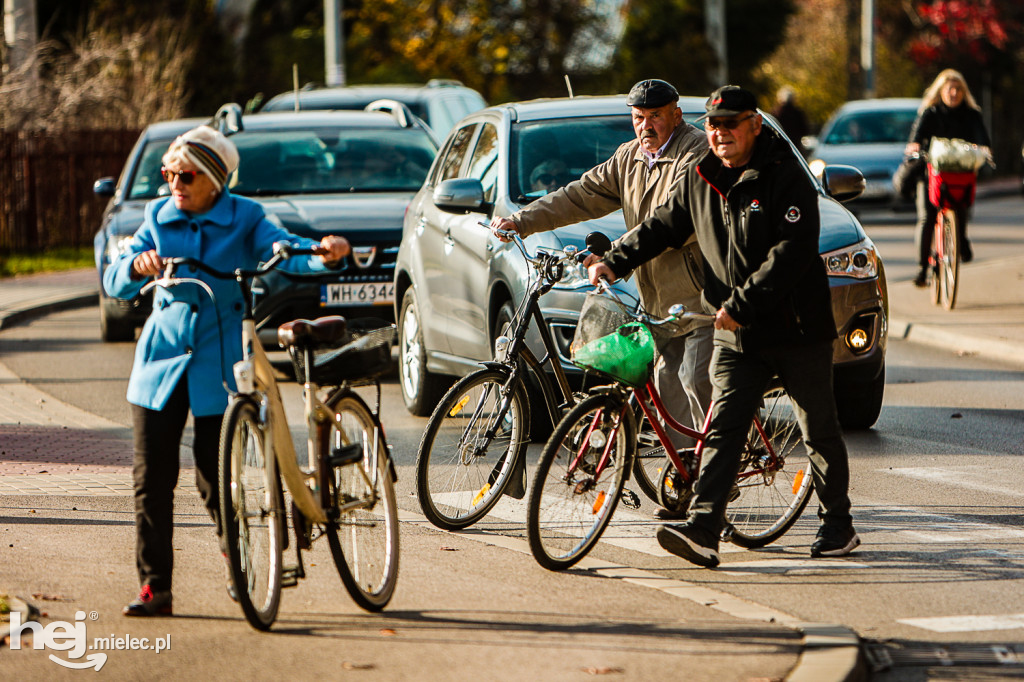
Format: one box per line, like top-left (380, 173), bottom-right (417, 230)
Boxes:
top-left (590, 85), bottom-right (860, 566)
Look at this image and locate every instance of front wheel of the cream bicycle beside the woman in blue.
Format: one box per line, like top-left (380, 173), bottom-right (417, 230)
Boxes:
top-left (218, 397), bottom-right (285, 630)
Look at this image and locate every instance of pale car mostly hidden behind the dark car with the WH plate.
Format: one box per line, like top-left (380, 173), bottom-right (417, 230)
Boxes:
top-left (260, 78), bottom-right (487, 139)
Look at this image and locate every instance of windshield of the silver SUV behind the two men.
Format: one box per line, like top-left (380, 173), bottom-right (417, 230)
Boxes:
top-left (509, 112), bottom-right (635, 204)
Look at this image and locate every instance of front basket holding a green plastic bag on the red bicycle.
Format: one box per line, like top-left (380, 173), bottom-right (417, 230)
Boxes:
top-left (569, 293), bottom-right (654, 387)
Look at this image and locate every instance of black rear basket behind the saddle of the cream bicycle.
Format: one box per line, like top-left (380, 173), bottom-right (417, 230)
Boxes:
top-left (289, 318), bottom-right (395, 386)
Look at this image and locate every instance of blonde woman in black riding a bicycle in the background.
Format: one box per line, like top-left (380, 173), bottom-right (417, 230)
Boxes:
top-left (904, 69), bottom-right (991, 287)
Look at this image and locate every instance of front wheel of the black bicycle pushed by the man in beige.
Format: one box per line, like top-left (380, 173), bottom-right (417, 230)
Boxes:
top-left (416, 369), bottom-right (529, 530)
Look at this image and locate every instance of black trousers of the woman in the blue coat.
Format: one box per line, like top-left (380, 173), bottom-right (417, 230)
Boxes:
top-left (132, 378), bottom-right (223, 591)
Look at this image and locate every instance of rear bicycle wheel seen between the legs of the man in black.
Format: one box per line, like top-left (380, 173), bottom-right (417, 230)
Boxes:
top-left (726, 387), bottom-right (814, 549)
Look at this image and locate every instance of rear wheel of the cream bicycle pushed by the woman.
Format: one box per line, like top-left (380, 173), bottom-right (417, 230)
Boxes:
top-left (325, 391), bottom-right (398, 611)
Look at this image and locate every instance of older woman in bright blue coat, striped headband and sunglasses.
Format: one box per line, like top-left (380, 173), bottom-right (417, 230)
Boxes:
top-left (103, 126), bottom-right (349, 615)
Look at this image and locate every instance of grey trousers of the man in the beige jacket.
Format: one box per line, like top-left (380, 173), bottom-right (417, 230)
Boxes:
top-left (654, 325), bottom-right (715, 450)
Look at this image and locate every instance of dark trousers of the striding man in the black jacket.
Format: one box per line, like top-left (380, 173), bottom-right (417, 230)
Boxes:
top-left (689, 342), bottom-right (853, 537)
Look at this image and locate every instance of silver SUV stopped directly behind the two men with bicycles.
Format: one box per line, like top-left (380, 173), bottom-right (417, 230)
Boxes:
top-left (395, 96), bottom-right (888, 427)
